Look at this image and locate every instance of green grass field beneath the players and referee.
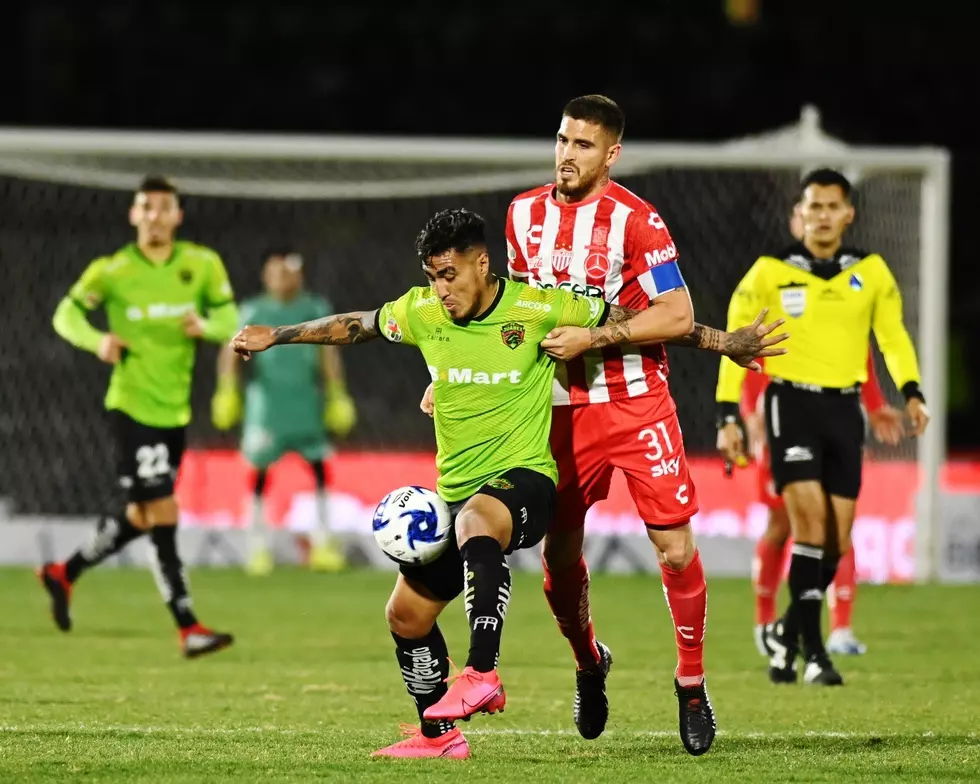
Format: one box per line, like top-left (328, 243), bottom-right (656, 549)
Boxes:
top-left (0, 569), bottom-right (980, 784)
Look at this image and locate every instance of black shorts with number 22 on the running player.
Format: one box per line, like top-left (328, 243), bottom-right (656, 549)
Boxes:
top-left (109, 411), bottom-right (186, 503)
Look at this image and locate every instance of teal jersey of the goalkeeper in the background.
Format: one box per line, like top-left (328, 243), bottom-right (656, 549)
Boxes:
top-left (239, 292), bottom-right (333, 434)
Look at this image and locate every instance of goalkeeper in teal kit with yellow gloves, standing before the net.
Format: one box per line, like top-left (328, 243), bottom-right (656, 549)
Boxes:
top-left (211, 248), bottom-right (357, 575)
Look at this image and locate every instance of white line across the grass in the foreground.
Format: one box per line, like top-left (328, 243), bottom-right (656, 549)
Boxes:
top-left (0, 723), bottom-right (960, 740)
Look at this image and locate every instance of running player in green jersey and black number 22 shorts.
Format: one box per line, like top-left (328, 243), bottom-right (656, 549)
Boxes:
top-left (39, 177), bottom-right (238, 658)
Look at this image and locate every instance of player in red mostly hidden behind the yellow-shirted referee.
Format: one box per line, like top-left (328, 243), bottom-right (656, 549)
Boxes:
top-left (740, 208), bottom-right (904, 656)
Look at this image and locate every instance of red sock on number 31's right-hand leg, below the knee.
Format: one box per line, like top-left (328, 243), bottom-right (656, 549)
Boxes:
top-left (660, 552), bottom-right (708, 686)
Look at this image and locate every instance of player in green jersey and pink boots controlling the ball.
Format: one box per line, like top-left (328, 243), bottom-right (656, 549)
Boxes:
top-left (232, 210), bottom-right (784, 757)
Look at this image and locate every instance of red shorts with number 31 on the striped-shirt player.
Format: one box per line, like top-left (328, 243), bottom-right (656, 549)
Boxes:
top-left (551, 395), bottom-right (698, 531)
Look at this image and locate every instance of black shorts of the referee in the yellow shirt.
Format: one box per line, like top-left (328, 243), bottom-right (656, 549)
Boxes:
top-left (765, 381), bottom-right (865, 498)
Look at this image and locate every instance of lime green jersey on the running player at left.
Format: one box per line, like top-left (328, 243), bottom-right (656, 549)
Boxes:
top-left (68, 242), bottom-right (236, 428)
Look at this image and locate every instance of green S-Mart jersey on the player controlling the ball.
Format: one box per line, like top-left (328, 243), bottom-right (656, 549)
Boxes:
top-left (378, 280), bottom-right (608, 503)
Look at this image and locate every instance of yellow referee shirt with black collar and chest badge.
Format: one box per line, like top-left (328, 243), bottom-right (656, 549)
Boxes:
top-left (715, 243), bottom-right (921, 404)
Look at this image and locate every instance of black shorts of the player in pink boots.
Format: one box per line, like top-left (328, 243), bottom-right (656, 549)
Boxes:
top-left (399, 468), bottom-right (557, 602)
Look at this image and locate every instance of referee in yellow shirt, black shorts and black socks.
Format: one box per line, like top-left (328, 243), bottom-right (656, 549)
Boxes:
top-left (716, 169), bottom-right (929, 686)
